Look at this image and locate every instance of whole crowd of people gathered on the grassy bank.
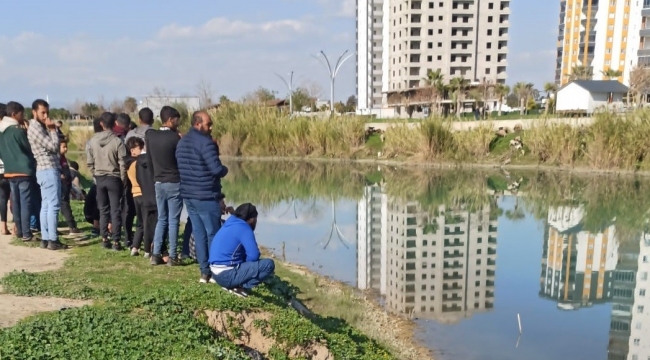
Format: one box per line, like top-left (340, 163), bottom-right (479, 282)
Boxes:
top-left (0, 99), bottom-right (275, 297)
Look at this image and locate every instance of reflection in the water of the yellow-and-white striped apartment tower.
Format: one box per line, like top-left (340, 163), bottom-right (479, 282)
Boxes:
top-left (540, 207), bottom-right (619, 309)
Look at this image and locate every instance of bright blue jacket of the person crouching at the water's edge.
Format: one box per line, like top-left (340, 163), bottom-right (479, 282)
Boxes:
top-left (208, 216), bottom-right (260, 266)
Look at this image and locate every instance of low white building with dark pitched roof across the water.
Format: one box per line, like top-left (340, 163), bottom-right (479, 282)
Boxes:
top-left (555, 80), bottom-right (628, 115)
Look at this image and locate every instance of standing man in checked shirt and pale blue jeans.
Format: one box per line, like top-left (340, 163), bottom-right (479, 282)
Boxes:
top-left (27, 99), bottom-right (66, 250)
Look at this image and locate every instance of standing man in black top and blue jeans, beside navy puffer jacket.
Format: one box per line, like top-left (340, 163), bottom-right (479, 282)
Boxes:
top-left (144, 106), bottom-right (183, 266)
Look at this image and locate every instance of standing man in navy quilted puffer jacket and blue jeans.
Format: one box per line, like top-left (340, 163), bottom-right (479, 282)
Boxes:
top-left (176, 111), bottom-right (228, 283)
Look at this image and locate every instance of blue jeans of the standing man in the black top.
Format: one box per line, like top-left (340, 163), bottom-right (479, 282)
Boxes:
top-left (153, 183), bottom-right (183, 258)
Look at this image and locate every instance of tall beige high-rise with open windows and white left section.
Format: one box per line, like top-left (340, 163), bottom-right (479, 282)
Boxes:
top-left (357, 0), bottom-right (510, 115)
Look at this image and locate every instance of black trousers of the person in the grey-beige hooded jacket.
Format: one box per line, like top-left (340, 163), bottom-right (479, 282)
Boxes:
top-left (95, 176), bottom-right (124, 242)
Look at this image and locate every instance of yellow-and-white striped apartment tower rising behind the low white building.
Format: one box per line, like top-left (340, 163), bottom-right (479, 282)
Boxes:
top-left (555, 0), bottom-right (650, 85)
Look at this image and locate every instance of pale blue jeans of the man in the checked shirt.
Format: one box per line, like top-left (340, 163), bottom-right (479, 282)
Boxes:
top-left (36, 169), bottom-right (61, 241)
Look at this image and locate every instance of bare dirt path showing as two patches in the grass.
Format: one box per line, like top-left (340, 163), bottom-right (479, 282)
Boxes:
top-left (0, 235), bottom-right (90, 327)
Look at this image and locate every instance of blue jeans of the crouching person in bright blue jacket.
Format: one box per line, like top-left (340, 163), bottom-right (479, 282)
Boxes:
top-left (213, 259), bottom-right (275, 290)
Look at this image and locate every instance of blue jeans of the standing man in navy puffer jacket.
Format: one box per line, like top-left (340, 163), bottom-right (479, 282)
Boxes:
top-left (185, 199), bottom-right (221, 275)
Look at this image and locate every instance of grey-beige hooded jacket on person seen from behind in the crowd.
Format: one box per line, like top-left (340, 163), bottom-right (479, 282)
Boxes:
top-left (86, 130), bottom-right (126, 182)
